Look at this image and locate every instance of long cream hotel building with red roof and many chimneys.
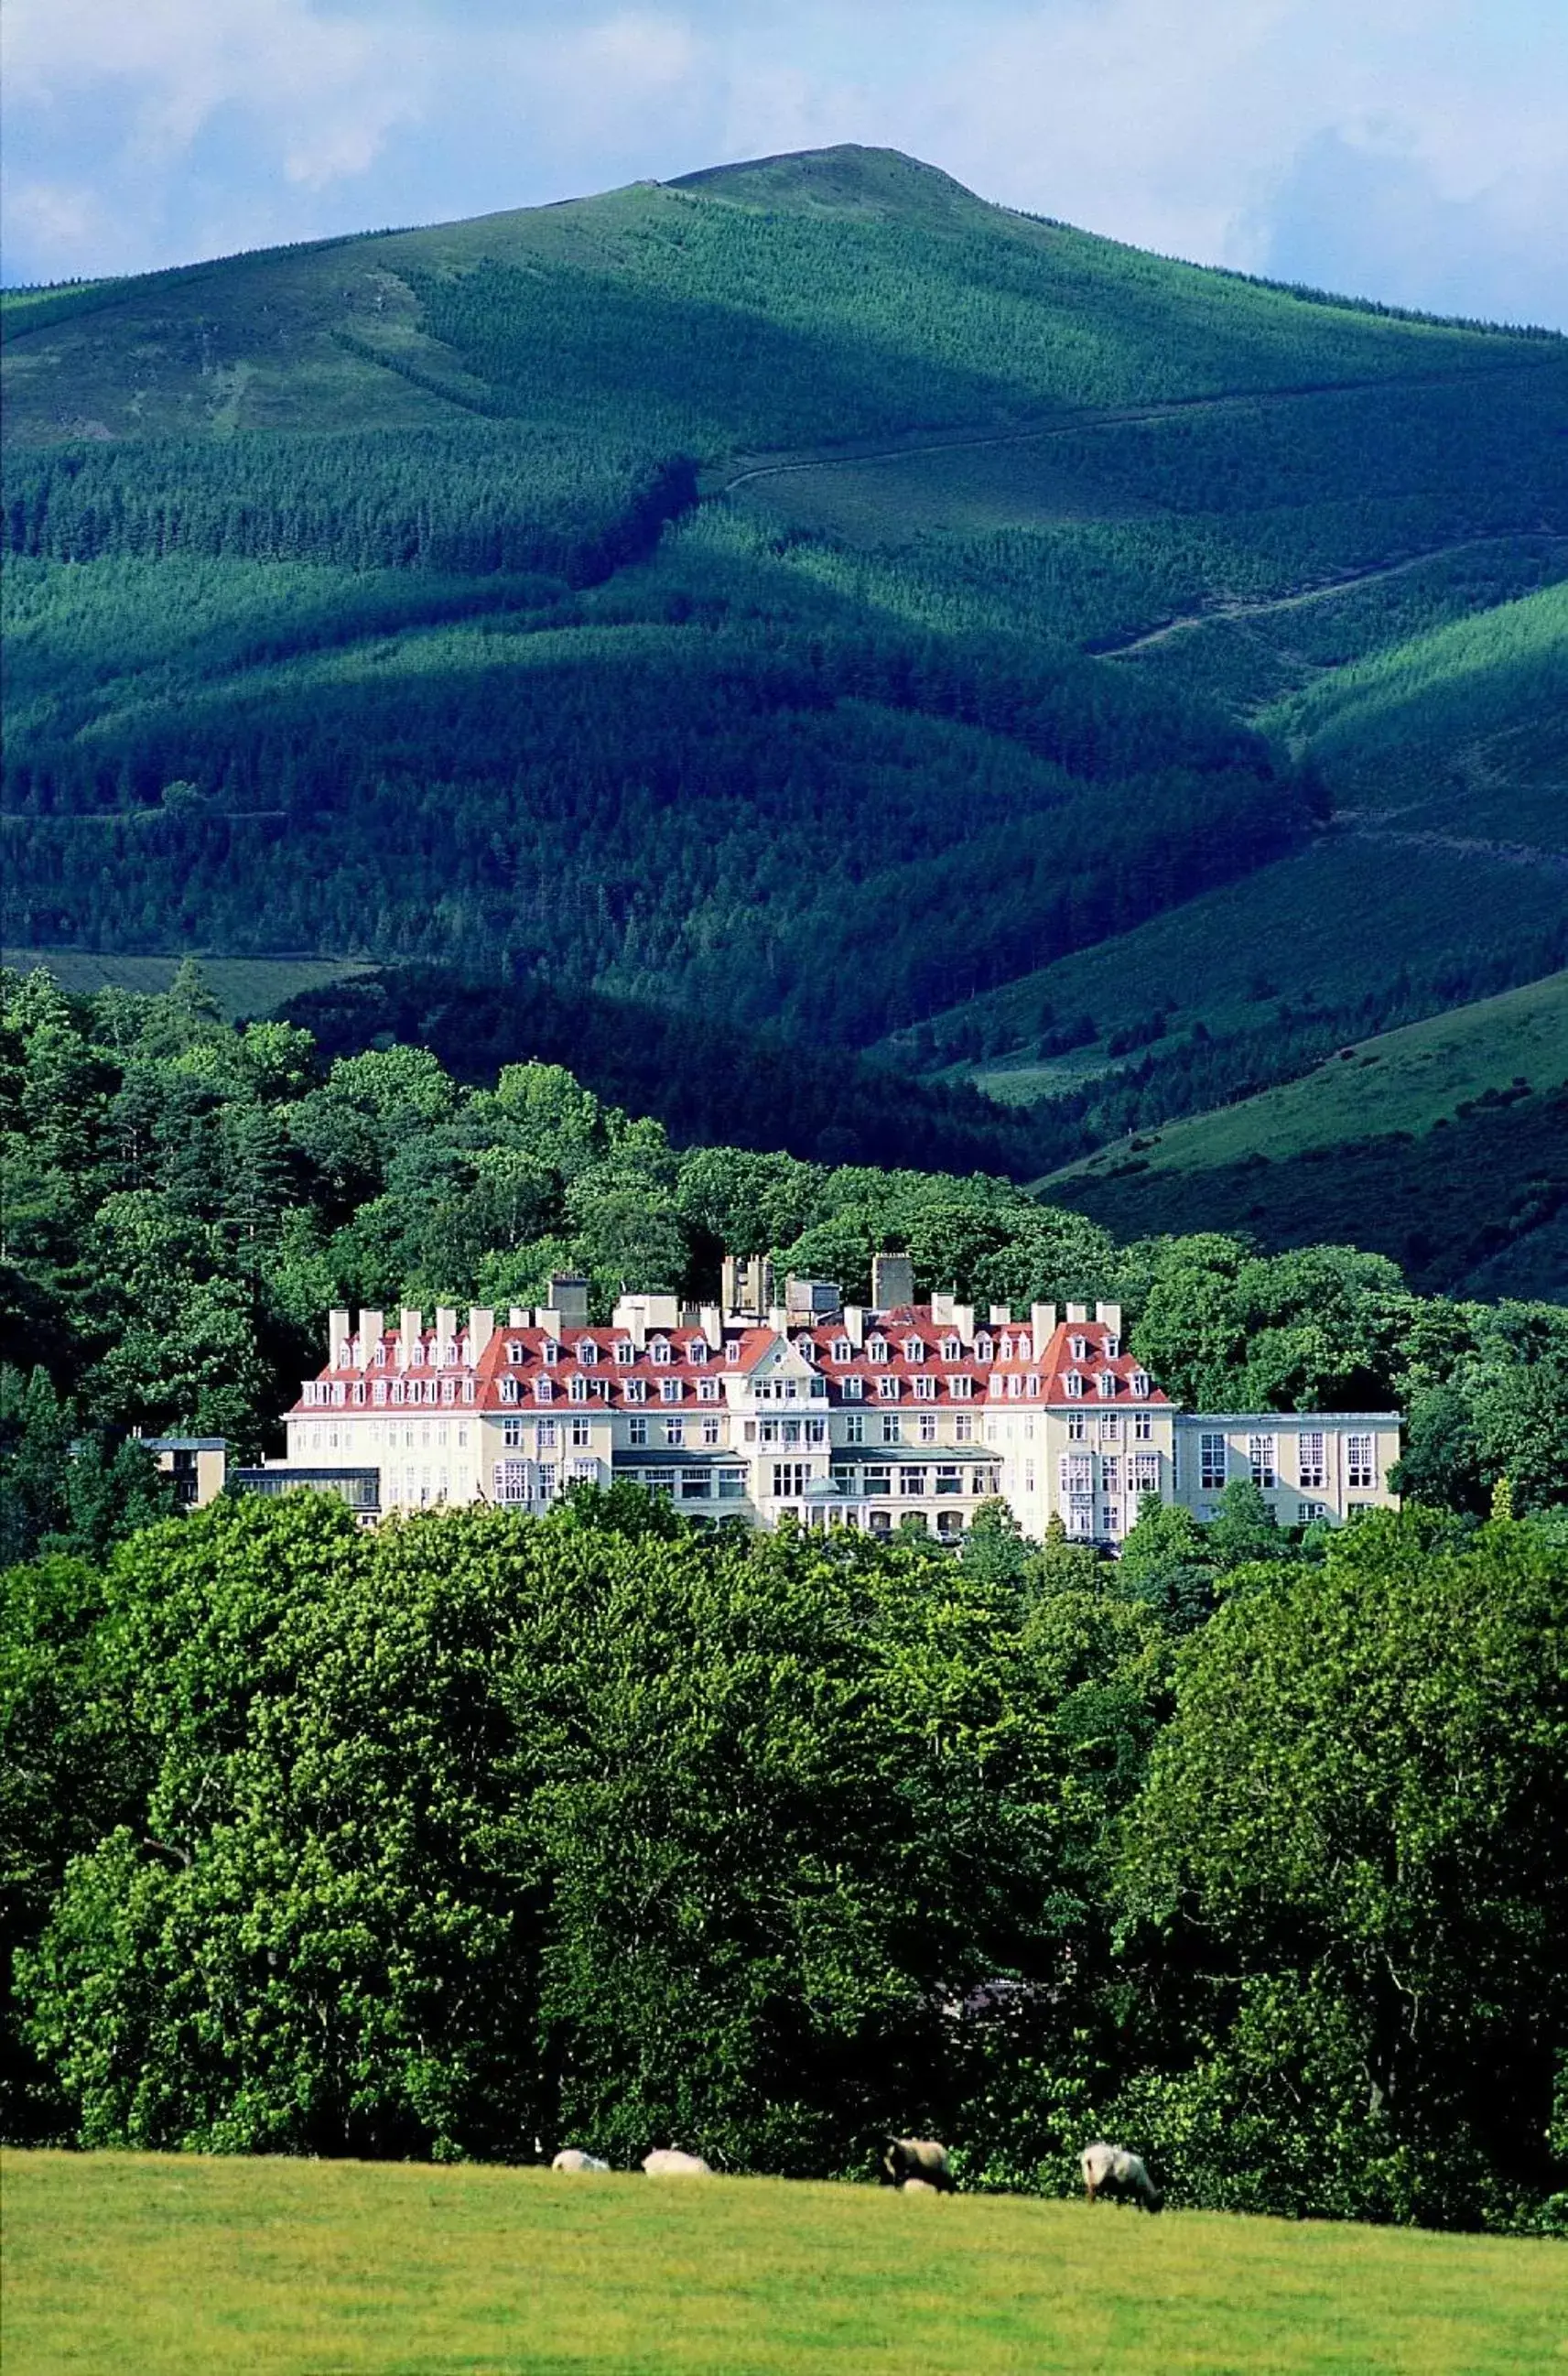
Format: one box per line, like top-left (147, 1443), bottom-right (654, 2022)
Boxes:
top-left (287, 1257), bottom-right (1400, 1546)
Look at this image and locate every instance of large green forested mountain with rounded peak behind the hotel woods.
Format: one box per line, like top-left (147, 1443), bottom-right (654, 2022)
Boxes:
top-left (3, 149), bottom-right (1568, 1235)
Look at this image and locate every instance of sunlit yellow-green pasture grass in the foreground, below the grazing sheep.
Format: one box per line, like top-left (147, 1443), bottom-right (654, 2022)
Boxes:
top-left (3, 2153), bottom-right (1568, 2376)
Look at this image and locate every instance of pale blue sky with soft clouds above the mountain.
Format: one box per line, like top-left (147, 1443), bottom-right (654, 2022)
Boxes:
top-left (0, 0), bottom-right (1568, 328)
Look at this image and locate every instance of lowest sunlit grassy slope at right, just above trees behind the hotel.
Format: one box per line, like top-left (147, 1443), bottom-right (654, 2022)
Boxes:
top-left (1053, 974), bottom-right (1568, 1183)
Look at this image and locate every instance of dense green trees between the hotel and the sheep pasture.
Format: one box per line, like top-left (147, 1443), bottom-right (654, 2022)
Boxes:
top-left (0, 1487), bottom-right (1568, 2236)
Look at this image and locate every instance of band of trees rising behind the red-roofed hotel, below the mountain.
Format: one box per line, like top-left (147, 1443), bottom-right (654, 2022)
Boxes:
top-left (0, 967), bottom-right (1568, 1557)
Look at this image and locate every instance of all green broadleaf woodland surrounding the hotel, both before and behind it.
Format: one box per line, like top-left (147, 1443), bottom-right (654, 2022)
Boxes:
top-left (0, 967), bottom-right (1568, 2229)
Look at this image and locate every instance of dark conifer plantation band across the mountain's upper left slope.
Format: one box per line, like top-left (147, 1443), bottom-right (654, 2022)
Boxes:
top-left (5, 423), bottom-right (696, 584)
